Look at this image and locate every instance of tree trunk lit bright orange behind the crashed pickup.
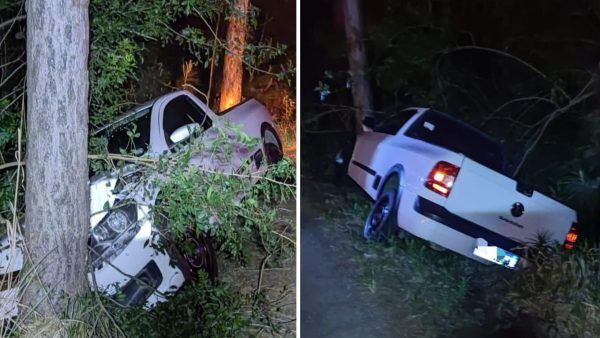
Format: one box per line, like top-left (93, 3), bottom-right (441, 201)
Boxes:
top-left (219, 0), bottom-right (249, 111)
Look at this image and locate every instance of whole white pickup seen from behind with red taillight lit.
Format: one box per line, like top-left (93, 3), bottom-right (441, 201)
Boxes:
top-left (348, 108), bottom-right (577, 268)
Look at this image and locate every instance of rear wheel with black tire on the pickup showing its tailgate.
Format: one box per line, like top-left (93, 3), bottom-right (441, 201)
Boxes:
top-left (363, 175), bottom-right (400, 241)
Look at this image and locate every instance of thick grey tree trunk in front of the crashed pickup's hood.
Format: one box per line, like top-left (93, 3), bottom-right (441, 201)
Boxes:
top-left (23, 0), bottom-right (90, 316)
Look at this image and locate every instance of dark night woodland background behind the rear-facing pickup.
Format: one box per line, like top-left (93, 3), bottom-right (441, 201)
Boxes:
top-left (301, 0), bottom-right (600, 240)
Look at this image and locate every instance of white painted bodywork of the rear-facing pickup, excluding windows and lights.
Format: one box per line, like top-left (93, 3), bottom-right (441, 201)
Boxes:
top-left (348, 108), bottom-right (577, 262)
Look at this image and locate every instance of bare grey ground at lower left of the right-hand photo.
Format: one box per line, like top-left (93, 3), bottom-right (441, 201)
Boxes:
top-left (300, 181), bottom-right (406, 337)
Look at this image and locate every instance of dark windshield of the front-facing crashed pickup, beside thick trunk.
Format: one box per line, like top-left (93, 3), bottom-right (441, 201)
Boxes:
top-left (98, 107), bottom-right (152, 155)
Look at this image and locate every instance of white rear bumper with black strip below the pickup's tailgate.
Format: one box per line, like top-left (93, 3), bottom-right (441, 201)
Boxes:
top-left (398, 191), bottom-right (521, 264)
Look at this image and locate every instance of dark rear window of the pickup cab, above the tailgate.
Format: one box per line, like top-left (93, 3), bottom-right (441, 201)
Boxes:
top-left (405, 110), bottom-right (503, 172)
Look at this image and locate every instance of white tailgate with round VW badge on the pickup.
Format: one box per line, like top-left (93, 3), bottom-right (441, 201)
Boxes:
top-left (445, 157), bottom-right (577, 249)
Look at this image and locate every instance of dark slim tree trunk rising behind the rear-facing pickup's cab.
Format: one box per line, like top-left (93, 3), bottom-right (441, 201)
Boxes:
top-left (342, 0), bottom-right (373, 131)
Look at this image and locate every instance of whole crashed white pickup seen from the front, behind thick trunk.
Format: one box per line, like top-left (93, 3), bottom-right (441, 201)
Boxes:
top-left (0, 91), bottom-right (283, 320)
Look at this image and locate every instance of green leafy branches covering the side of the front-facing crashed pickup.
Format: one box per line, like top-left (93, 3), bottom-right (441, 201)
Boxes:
top-left (149, 124), bottom-right (295, 258)
